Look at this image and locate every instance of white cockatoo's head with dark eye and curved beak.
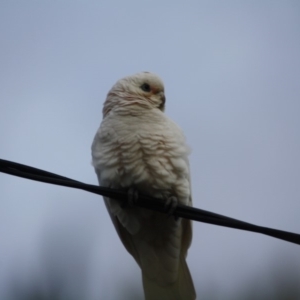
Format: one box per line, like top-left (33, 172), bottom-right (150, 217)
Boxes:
top-left (103, 72), bottom-right (166, 116)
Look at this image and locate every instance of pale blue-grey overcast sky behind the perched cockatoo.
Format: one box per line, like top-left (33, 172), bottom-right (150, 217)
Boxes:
top-left (0, 0), bottom-right (300, 300)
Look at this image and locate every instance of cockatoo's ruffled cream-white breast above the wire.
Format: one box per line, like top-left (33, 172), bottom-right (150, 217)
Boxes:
top-left (92, 113), bottom-right (190, 203)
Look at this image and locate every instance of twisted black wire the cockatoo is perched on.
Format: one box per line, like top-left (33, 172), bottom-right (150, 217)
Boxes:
top-left (0, 159), bottom-right (300, 245)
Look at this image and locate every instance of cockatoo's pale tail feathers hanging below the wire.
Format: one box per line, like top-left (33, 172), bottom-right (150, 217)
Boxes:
top-left (142, 257), bottom-right (196, 300)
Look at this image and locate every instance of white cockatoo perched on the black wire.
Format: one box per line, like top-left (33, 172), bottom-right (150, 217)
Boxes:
top-left (92, 72), bottom-right (196, 300)
